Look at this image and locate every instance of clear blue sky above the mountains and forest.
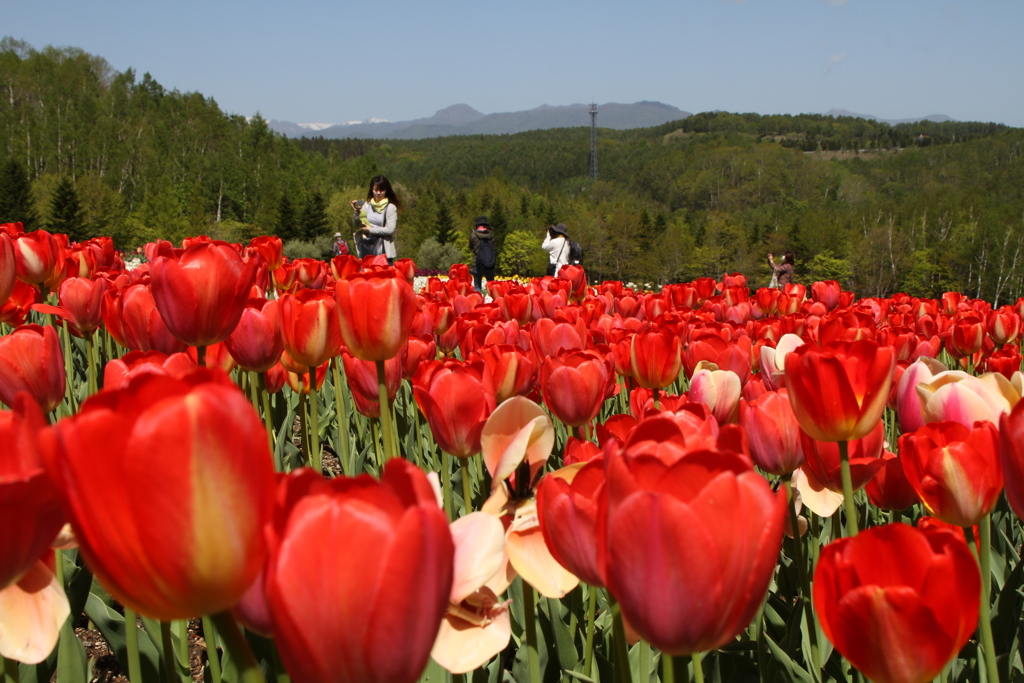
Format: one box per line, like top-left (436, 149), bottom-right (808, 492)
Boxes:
top-left (0, 0), bottom-right (1024, 127)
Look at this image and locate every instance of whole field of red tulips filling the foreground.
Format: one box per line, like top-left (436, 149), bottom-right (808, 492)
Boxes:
top-left (6, 223), bottom-right (1024, 683)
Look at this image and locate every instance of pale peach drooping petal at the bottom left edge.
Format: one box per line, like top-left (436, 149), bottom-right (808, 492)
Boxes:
top-left (0, 561), bottom-right (71, 664)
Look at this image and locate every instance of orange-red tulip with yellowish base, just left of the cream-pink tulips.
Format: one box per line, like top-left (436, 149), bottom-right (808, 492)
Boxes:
top-left (785, 340), bottom-right (896, 441)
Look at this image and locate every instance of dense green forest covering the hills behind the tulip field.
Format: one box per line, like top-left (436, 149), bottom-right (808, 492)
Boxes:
top-left (0, 38), bottom-right (1024, 303)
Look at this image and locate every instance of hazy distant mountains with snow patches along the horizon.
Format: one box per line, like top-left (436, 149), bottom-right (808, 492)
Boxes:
top-left (268, 101), bottom-right (952, 139)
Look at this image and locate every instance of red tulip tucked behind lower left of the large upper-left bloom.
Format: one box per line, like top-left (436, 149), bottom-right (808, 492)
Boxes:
top-left (103, 282), bottom-right (188, 355)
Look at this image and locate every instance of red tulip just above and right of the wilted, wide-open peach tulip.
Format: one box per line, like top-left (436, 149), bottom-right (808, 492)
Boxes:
top-left (541, 351), bottom-right (615, 427)
